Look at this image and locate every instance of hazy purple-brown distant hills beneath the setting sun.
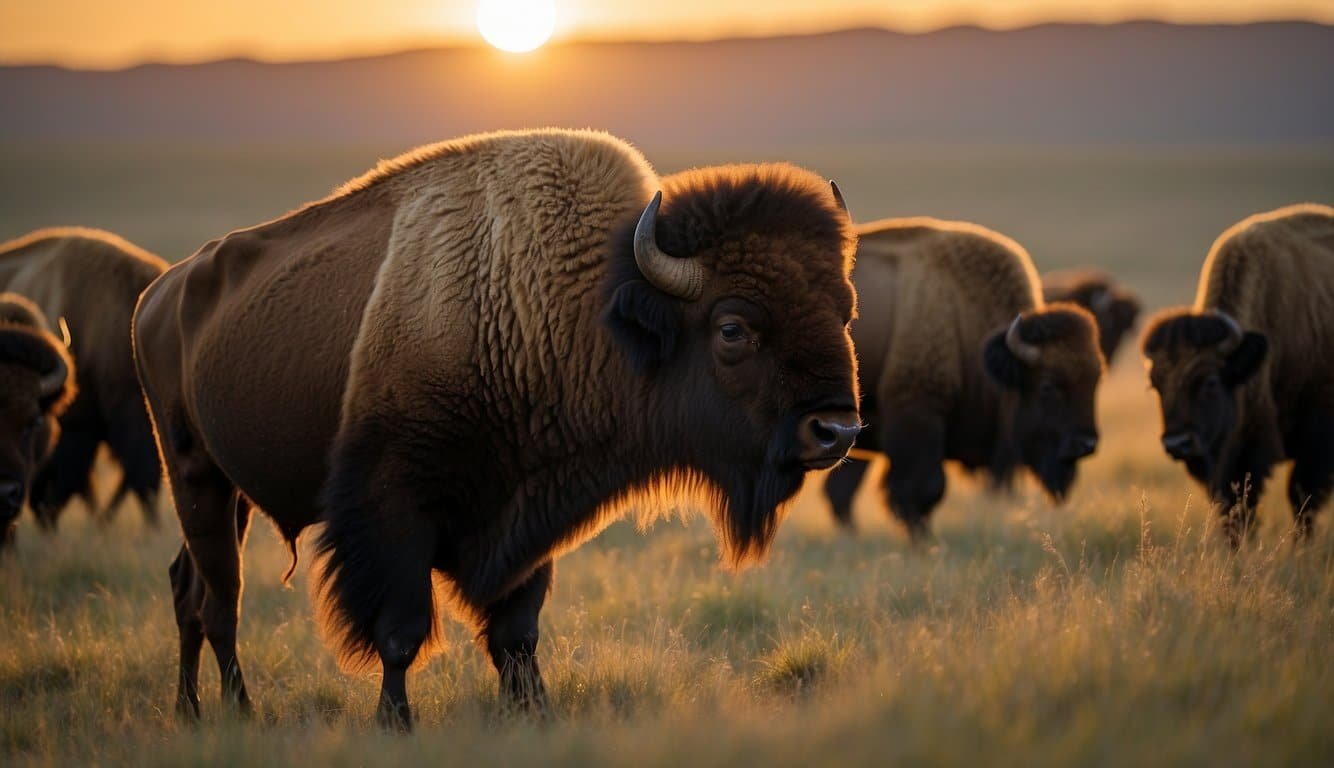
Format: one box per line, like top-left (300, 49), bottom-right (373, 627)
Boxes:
top-left (0, 23), bottom-right (1334, 147)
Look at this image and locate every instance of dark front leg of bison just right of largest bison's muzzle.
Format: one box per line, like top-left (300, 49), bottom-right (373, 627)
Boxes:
top-left (884, 408), bottom-right (944, 544)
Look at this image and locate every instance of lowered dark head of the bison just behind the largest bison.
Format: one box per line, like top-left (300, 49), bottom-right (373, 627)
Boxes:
top-left (983, 304), bottom-right (1103, 501)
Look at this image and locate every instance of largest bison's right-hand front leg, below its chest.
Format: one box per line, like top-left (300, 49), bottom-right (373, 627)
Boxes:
top-left (482, 561), bottom-right (555, 712)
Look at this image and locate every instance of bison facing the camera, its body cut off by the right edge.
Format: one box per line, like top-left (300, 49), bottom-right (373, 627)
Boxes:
top-left (1143, 205), bottom-right (1334, 545)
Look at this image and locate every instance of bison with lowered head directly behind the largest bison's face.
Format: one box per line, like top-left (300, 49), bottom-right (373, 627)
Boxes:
top-left (824, 219), bottom-right (1103, 540)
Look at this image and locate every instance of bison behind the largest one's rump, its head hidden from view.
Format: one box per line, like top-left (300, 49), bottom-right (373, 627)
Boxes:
top-left (0, 228), bottom-right (167, 528)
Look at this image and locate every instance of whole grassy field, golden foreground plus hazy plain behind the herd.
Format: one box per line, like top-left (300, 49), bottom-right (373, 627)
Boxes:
top-left (0, 145), bottom-right (1334, 765)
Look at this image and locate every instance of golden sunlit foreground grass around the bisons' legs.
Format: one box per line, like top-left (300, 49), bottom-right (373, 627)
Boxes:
top-left (0, 360), bottom-right (1334, 765)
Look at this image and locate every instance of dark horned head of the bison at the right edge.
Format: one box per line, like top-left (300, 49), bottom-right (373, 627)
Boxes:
top-left (1143, 311), bottom-right (1269, 483)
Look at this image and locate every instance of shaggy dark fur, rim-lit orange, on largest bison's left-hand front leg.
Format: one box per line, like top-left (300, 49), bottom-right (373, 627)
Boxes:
top-left (311, 482), bottom-right (440, 673)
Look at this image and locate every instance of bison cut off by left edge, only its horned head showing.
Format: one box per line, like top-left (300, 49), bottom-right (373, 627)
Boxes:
top-left (0, 293), bottom-right (75, 548)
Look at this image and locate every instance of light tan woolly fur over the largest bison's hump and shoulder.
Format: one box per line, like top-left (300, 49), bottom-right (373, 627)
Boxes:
top-left (344, 131), bottom-right (658, 449)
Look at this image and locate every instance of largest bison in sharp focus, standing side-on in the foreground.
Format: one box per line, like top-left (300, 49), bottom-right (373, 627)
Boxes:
top-left (135, 131), bottom-right (859, 725)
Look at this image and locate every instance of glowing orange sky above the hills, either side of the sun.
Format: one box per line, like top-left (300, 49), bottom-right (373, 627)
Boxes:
top-left (0, 0), bottom-right (1334, 68)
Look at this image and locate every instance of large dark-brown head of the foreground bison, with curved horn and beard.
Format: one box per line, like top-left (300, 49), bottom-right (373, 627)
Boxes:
top-left (606, 165), bottom-right (860, 561)
